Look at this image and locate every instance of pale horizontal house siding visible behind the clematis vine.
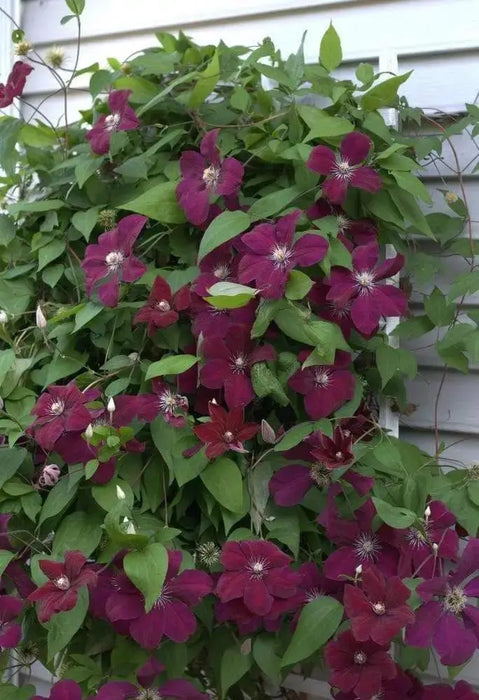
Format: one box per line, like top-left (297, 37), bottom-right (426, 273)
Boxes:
top-left (10, 0), bottom-right (479, 697)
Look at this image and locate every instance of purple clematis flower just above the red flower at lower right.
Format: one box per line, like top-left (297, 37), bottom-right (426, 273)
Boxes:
top-left (319, 499), bottom-right (399, 581)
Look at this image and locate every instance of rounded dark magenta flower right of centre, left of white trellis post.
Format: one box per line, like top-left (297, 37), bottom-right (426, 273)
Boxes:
top-left (288, 350), bottom-right (356, 420)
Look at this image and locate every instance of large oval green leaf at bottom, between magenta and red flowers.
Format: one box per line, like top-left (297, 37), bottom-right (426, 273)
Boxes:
top-left (281, 596), bottom-right (343, 666)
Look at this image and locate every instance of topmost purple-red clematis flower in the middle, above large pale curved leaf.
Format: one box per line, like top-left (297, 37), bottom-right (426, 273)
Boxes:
top-left (176, 129), bottom-right (244, 226)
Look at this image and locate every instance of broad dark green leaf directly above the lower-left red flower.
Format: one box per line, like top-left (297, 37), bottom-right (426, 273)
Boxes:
top-left (53, 510), bottom-right (103, 557)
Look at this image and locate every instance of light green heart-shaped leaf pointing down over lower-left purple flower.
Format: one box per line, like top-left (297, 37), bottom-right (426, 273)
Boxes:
top-left (123, 542), bottom-right (168, 612)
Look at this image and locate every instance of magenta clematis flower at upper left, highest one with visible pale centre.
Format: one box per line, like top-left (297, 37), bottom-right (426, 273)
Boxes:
top-left (86, 90), bottom-right (140, 155)
